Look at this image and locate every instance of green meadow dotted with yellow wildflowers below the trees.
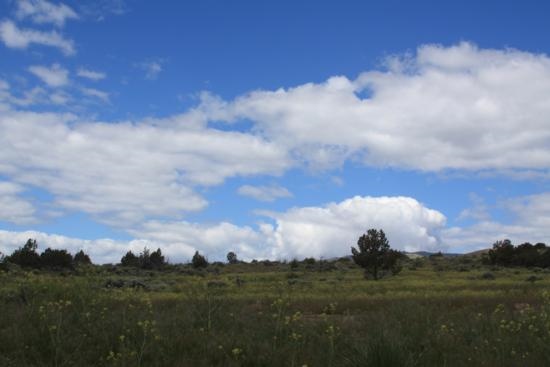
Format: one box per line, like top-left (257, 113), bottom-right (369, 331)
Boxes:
top-left (0, 257), bottom-right (550, 367)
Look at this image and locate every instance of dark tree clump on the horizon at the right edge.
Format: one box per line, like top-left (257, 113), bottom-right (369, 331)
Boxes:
top-left (483, 239), bottom-right (550, 268)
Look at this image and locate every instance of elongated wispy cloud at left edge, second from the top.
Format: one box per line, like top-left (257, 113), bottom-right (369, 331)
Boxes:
top-left (0, 20), bottom-right (76, 55)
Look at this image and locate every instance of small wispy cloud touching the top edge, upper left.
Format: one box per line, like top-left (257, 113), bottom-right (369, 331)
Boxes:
top-left (16, 0), bottom-right (78, 27)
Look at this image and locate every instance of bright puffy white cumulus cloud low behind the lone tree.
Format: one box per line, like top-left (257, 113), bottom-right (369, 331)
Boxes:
top-left (263, 196), bottom-right (446, 259)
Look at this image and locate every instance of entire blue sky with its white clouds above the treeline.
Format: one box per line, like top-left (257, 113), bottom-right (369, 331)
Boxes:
top-left (0, 0), bottom-right (550, 263)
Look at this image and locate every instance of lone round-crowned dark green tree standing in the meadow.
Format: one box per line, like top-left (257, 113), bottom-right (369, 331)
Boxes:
top-left (351, 229), bottom-right (402, 280)
